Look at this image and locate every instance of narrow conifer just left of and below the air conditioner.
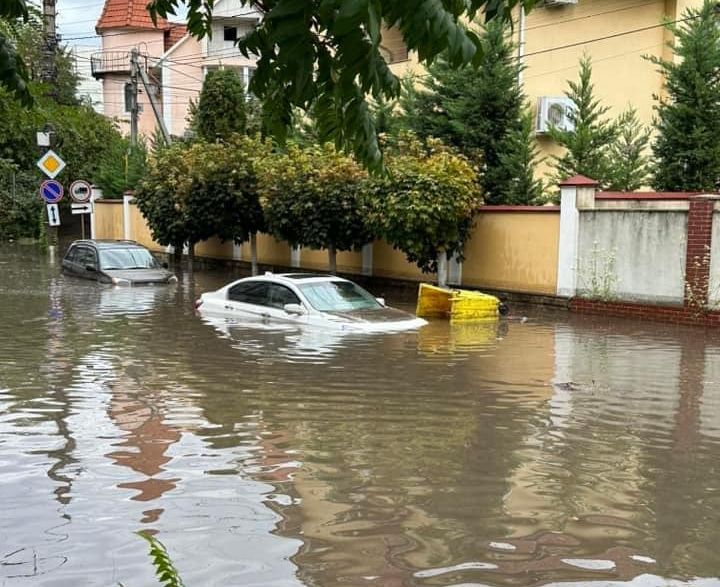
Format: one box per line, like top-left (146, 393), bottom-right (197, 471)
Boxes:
top-left (497, 111), bottom-right (545, 205)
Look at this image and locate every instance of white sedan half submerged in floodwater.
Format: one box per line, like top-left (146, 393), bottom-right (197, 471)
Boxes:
top-left (195, 273), bottom-right (427, 332)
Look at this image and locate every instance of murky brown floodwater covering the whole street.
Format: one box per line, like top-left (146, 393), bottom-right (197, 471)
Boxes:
top-left (0, 246), bottom-right (720, 587)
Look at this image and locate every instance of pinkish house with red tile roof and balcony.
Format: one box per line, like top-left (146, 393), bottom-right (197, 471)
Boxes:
top-left (91, 0), bottom-right (261, 137)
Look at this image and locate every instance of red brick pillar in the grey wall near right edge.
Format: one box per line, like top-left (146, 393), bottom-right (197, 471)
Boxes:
top-left (685, 196), bottom-right (715, 308)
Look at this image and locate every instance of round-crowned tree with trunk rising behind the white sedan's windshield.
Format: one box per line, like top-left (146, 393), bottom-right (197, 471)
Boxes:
top-left (261, 145), bottom-right (373, 274)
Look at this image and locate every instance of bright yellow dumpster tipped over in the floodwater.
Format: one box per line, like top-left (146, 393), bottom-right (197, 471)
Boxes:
top-left (415, 283), bottom-right (501, 322)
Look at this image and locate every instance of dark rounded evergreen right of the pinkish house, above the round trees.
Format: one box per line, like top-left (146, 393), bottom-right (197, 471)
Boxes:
top-left (190, 69), bottom-right (247, 141)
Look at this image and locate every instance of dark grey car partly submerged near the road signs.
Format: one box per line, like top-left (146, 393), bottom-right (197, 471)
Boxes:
top-left (63, 240), bottom-right (177, 285)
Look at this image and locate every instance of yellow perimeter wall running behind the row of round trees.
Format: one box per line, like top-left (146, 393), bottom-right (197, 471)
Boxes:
top-left (95, 200), bottom-right (560, 295)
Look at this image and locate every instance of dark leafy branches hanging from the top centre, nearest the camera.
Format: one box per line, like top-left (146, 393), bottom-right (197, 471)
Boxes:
top-left (149, 0), bottom-right (535, 168)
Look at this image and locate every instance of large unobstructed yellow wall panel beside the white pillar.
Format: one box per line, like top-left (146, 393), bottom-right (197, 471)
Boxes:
top-left (462, 212), bottom-right (560, 295)
